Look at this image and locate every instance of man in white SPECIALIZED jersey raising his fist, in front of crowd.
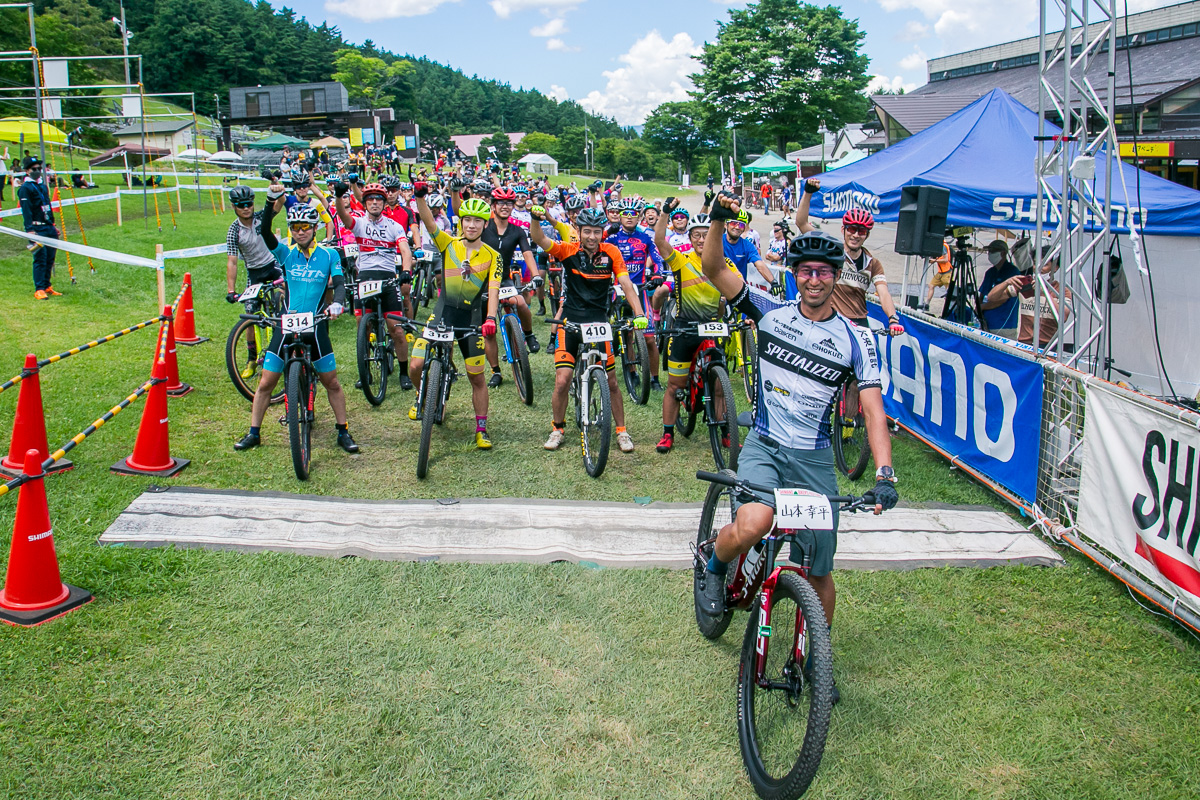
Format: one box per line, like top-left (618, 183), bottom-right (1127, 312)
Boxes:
top-left (697, 193), bottom-right (899, 697)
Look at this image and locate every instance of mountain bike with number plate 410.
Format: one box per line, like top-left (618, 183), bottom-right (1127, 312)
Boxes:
top-left (554, 321), bottom-right (612, 477)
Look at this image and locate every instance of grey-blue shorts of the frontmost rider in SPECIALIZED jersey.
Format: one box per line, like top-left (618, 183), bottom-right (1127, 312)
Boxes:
top-left (733, 432), bottom-right (838, 578)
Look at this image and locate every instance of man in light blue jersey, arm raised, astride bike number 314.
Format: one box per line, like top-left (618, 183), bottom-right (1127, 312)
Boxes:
top-left (234, 184), bottom-right (359, 453)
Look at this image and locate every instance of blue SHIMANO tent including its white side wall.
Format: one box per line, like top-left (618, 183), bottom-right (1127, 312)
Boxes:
top-left (810, 89), bottom-right (1200, 395)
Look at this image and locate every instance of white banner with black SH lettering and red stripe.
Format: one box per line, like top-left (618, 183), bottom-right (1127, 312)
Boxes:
top-left (1079, 384), bottom-right (1200, 613)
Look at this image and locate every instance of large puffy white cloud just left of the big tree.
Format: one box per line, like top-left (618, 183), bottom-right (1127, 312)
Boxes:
top-left (580, 30), bottom-right (700, 125)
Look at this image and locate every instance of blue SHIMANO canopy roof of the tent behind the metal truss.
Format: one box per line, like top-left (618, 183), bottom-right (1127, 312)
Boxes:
top-left (810, 89), bottom-right (1200, 236)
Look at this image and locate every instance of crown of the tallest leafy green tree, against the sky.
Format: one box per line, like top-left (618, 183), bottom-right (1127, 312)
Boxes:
top-left (692, 0), bottom-right (870, 155)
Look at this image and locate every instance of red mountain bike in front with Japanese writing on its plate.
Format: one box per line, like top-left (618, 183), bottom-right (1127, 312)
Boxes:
top-left (692, 470), bottom-right (875, 800)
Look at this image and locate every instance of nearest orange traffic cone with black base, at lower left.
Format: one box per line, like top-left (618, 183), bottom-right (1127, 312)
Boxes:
top-left (0, 449), bottom-right (91, 626)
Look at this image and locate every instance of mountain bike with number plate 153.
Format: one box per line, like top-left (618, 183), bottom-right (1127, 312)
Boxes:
top-left (664, 319), bottom-right (749, 469)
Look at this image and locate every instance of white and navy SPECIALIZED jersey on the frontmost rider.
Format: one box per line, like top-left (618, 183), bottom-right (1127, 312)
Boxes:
top-left (733, 287), bottom-right (880, 450)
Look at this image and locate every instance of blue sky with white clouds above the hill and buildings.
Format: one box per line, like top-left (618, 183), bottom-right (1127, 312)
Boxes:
top-left (271, 0), bottom-right (1170, 125)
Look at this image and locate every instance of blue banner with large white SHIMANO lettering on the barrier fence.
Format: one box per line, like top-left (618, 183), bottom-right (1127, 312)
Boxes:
top-left (868, 303), bottom-right (1044, 503)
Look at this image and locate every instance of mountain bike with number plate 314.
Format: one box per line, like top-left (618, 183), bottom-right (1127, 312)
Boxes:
top-left (241, 312), bottom-right (330, 481)
